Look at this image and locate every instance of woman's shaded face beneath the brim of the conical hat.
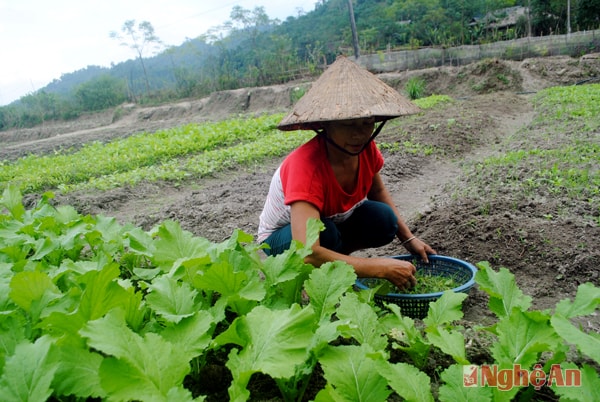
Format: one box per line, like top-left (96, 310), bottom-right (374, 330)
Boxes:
top-left (325, 118), bottom-right (375, 153)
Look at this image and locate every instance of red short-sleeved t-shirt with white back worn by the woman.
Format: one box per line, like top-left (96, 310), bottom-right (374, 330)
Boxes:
top-left (258, 135), bottom-right (383, 242)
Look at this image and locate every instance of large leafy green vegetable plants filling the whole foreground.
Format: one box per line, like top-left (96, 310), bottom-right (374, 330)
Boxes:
top-left (0, 181), bottom-right (600, 401)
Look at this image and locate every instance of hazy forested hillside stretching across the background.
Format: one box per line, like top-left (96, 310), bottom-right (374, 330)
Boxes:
top-left (0, 0), bottom-right (600, 130)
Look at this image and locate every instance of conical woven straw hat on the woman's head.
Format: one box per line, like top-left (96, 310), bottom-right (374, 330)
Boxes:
top-left (277, 56), bottom-right (420, 131)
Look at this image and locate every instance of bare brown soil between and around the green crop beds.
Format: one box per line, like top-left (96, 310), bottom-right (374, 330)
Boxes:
top-left (0, 57), bottom-right (600, 398)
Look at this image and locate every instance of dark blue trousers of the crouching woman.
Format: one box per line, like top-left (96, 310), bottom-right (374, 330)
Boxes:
top-left (264, 200), bottom-right (398, 255)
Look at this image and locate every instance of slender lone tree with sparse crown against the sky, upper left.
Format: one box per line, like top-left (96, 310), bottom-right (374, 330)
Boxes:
top-left (109, 20), bottom-right (162, 97)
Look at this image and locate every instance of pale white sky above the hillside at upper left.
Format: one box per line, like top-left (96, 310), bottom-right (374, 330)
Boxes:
top-left (0, 0), bottom-right (318, 106)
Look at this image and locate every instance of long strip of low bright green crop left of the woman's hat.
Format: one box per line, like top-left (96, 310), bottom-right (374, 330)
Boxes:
top-left (0, 114), bottom-right (314, 193)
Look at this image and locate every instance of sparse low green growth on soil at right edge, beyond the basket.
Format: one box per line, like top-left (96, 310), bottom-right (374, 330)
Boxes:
top-left (460, 85), bottom-right (600, 225)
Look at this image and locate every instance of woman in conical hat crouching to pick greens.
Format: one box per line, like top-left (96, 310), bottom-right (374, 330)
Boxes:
top-left (258, 57), bottom-right (435, 288)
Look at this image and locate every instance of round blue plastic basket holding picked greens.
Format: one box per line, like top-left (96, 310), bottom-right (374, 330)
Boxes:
top-left (356, 254), bottom-right (477, 319)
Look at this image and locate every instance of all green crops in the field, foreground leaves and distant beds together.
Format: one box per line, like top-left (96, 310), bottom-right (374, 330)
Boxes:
top-left (0, 85), bottom-right (600, 402)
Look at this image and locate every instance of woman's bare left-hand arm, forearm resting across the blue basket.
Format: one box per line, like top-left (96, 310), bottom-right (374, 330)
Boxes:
top-left (291, 201), bottom-right (416, 288)
